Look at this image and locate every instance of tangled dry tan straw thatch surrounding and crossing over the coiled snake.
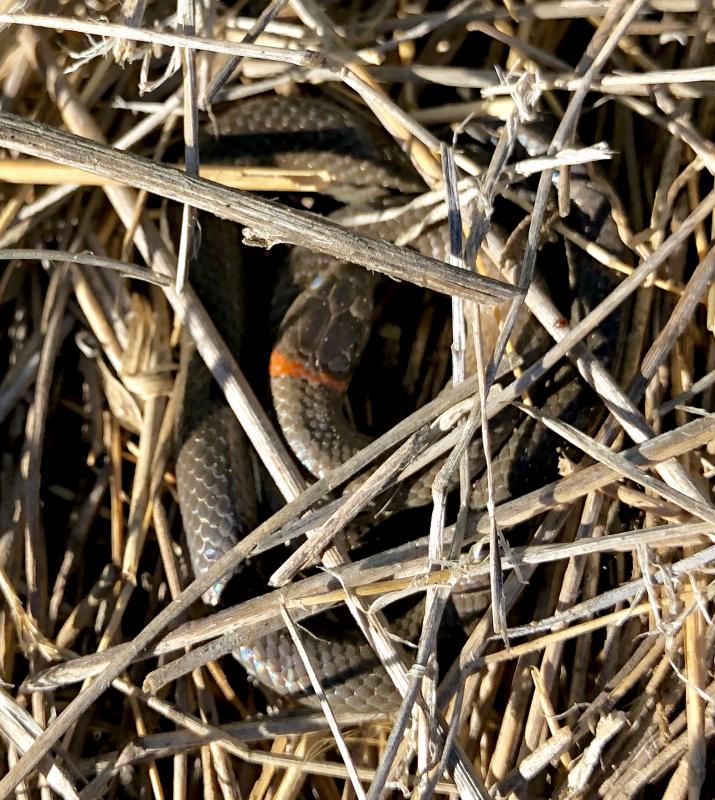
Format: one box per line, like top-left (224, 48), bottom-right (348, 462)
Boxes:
top-left (0, 0), bottom-right (715, 800)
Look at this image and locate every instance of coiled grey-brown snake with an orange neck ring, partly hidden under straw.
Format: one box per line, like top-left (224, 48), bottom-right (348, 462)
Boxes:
top-left (176, 96), bottom-right (623, 713)
